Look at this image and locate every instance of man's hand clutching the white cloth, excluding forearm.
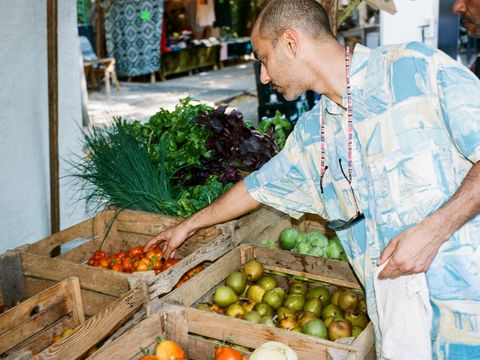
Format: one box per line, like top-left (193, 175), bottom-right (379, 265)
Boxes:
top-left (377, 218), bottom-right (446, 279)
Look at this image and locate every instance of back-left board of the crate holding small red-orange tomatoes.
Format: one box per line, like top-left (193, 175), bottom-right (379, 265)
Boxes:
top-left (23, 219), bottom-right (94, 256)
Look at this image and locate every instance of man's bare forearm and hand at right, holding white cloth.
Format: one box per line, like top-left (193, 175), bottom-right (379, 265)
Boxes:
top-left (377, 162), bottom-right (480, 279)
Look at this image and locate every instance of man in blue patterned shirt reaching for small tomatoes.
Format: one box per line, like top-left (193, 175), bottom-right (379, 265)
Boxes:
top-left (146, 0), bottom-right (480, 359)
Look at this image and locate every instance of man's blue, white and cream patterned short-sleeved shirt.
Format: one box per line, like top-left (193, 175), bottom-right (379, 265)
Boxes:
top-left (245, 43), bottom-right (480, 359)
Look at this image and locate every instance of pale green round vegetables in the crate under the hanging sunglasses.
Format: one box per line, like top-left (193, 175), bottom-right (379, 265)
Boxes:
top-left (262, 227), bottom-right (348, 261)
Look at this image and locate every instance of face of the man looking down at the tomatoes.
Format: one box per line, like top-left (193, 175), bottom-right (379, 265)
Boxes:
top-left (252, 32), bottom-right (304, 101)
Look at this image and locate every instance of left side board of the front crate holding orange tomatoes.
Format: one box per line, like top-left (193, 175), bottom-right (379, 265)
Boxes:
top-left (89, 313), bottom-right (159, 360)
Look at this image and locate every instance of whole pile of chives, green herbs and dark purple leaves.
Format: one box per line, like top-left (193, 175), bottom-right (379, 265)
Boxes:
top-left (70, 98), bottom-right (291, 217)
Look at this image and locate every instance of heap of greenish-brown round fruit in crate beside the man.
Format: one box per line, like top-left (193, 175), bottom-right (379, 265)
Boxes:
top-left (196, 260), bottom-right (369, 341)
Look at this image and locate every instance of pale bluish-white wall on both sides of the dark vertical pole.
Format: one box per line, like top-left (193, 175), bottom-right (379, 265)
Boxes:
top-left (0, 0), bottom-right (86, 253)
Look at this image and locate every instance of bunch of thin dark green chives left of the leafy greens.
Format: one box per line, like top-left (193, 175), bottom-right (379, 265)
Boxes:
top-left (67, 118), bottom-right (180, 215)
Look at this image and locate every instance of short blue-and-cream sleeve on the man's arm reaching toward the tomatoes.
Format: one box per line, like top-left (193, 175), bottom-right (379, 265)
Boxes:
top-left (244, 112), bottom-right (323, 218)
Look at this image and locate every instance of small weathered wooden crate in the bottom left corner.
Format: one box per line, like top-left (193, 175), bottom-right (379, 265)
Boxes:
top-left (0, 277), bottom-right (147, 360)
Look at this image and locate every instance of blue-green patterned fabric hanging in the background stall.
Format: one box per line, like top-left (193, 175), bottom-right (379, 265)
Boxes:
top-left (102, 0), bottom-right (163, 76)
